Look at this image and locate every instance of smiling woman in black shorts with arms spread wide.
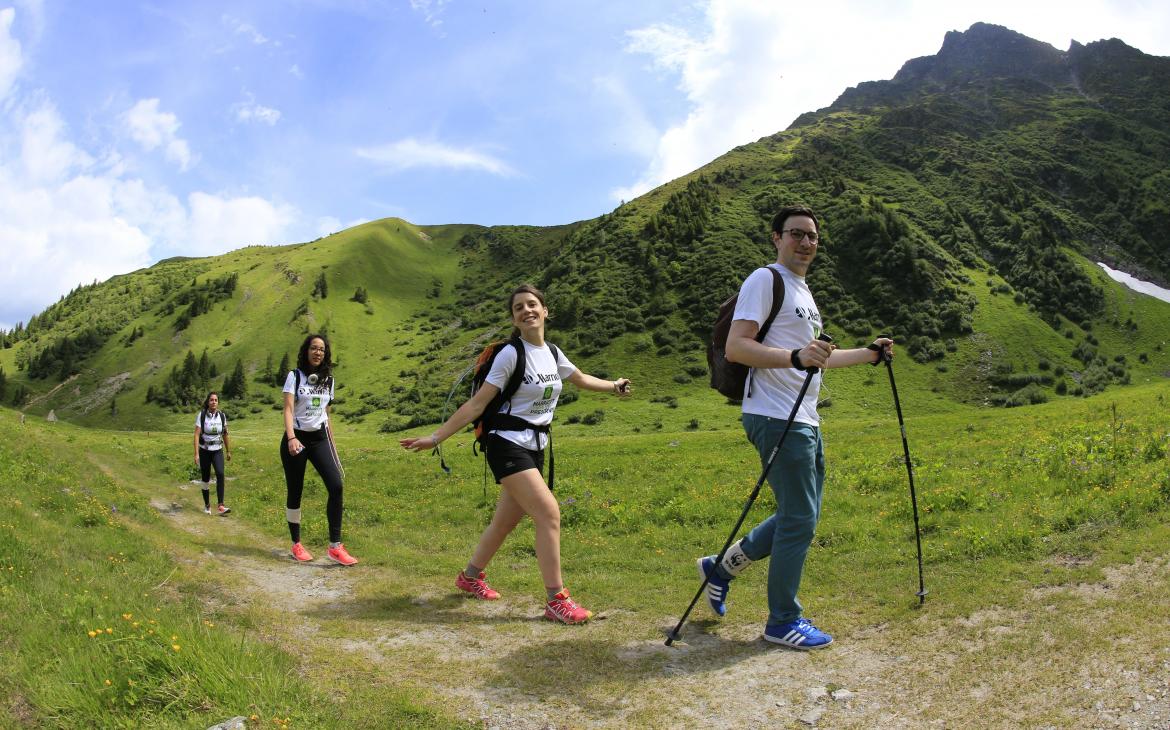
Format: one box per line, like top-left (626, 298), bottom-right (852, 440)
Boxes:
top-left (400, 284), bottom-right (629, 624)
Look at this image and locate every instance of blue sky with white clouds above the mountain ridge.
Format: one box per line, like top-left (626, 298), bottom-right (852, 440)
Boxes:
top-left (0, 0), bottom-right (1170, 329)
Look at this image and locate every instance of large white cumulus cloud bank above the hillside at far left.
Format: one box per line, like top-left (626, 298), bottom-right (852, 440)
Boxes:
top-left (0, 99), bottom-right (297, 329)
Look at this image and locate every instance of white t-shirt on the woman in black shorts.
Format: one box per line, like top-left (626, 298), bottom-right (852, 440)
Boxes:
top-left (486, 339), bottom-right (577, 452)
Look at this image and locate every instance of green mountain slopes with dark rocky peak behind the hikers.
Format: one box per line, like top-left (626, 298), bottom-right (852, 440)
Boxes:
top-left (0, 23), bottom-right (1170, 432)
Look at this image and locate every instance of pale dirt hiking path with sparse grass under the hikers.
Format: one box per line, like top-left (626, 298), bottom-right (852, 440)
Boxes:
top-left (91, 456), bottom-right (1170, 729)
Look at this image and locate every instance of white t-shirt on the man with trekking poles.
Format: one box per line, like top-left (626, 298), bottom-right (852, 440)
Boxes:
top-left (732, 263), bottom-right (821, 426)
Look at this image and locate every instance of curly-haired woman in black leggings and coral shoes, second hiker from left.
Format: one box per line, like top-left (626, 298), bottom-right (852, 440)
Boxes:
top-left (281, 335), bottom-right (358, 565)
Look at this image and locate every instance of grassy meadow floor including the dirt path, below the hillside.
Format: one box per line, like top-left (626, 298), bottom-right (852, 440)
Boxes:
top-left (0, 369), bottom-right (1170, 728)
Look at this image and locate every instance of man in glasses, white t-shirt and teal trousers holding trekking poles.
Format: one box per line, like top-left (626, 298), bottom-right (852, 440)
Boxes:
top-left (698, 206), bottom-right (894, 649)
